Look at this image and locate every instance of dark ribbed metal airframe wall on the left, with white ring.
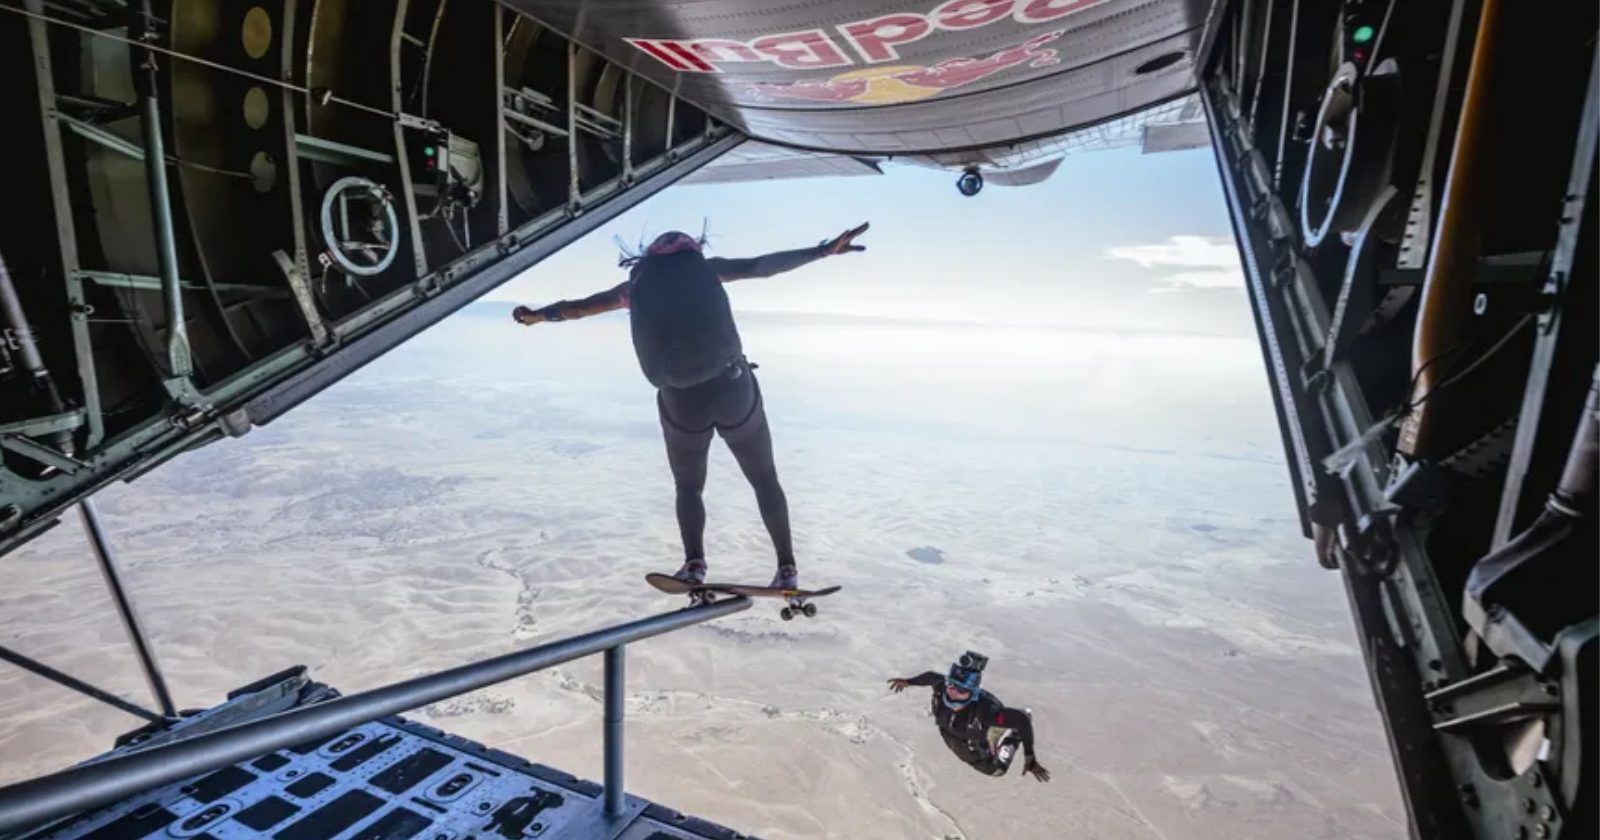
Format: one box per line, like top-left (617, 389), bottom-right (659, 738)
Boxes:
top-left (0, 0), bottom-right (744, 554)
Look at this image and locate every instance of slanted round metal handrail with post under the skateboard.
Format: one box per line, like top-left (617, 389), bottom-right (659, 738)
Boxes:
top-left (0, 597), bottom-right (750, 834)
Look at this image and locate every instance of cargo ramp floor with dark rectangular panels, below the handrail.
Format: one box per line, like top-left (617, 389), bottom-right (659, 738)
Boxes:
top-left (26, 675), bottom-right (739, 840)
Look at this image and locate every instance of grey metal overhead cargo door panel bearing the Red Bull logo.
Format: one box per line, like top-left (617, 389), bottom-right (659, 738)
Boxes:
top-left (507, 0), bottom-right (1205, 155)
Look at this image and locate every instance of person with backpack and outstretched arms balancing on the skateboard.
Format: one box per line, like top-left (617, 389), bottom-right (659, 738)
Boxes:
top-left (512, 224), bottom-right (867, 589)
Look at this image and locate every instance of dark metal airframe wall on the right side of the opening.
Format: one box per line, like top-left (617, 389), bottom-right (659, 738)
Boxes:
top-left (1198, 0), bottom-right (1600, 838)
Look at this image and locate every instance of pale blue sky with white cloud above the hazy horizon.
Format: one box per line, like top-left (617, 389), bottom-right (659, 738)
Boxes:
top-left (490, 149), bottom-right (1251, 336)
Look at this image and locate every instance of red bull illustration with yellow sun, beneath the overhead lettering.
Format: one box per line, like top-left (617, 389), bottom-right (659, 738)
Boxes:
top-left (739, 29), bottom-right (1066, 106)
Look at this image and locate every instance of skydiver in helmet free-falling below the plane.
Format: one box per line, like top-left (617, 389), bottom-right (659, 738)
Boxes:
top-left (890, 651), bottom-right (1050, 782)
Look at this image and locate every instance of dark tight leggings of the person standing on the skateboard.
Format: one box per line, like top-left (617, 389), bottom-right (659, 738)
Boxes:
top-left (656, 363), bottom-right (795, 566)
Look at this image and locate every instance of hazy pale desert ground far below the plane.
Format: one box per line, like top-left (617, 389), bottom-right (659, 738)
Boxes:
top-left (0, 304), bottom-right (1405, 840)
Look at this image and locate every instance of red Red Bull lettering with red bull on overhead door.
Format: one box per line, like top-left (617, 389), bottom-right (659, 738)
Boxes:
top-left (624, 0), bottom-right (1106, 74)
